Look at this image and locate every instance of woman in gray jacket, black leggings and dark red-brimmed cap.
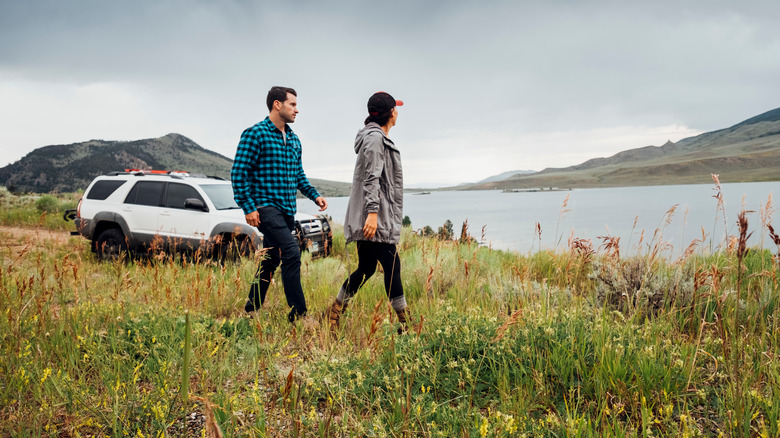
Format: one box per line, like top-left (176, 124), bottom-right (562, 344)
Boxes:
top-left (328, 91), bottom-right (410, 334)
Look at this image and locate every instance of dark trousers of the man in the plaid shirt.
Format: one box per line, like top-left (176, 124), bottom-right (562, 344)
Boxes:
top-left (249, 207), bottom-right (306, 322)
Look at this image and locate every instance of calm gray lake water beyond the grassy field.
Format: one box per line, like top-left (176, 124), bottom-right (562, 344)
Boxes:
top-left (298, 182), bottom-right (780, 256)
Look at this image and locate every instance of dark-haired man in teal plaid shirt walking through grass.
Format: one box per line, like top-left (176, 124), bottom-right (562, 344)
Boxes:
top-left (230, 87), bottom-right (328, 322)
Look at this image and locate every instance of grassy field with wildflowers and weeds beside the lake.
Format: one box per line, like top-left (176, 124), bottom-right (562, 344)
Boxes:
top-left (0, 187), bottom-right (780, 437)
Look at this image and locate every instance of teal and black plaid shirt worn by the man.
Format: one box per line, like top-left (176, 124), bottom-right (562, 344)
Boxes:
top-left (230, 117), bottom-right (320, 216)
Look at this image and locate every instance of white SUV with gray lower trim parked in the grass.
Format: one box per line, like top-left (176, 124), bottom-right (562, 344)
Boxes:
top-left (65, 169), bottom-right (332, 260)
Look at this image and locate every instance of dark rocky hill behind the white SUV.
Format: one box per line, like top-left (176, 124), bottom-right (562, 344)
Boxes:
top-left (0, 134), bottom-right (350, 196)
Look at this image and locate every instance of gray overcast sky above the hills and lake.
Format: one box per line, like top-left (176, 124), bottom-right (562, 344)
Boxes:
top-left (0, 0), bottom-right (780, 186)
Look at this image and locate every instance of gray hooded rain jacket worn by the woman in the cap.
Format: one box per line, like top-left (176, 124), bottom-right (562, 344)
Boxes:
top-left (344, 122), bottom-right (404, 244)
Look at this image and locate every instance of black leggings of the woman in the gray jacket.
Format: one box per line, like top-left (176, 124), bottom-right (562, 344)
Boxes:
top-left (342, 240), bottom-right (404, 300)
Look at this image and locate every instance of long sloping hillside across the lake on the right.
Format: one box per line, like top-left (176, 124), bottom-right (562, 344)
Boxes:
top-left (468, 108), bottom-right (780, 190)
